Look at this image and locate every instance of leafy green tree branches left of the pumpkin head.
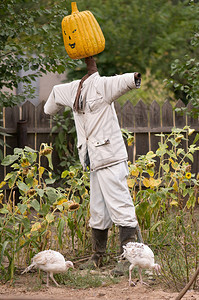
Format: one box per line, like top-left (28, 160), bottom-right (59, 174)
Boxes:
top-left (0, 0), bottom-right (74, 106)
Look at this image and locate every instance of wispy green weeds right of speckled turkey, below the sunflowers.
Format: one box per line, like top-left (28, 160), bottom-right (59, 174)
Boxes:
top-left (155, 210), bottom-right (199, 291)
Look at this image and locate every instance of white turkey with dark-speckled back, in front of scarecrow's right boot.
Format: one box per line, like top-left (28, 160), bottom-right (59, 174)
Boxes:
top-left (121, 242), bottom-right (160, 286)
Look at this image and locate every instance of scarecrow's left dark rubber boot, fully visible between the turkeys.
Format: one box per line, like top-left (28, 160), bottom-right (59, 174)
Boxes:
top-left (79, 228), bottom-right (108, 270)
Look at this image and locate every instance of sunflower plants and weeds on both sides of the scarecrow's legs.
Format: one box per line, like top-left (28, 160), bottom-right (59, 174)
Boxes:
top-left (0, 126), bottom-right (199, 290)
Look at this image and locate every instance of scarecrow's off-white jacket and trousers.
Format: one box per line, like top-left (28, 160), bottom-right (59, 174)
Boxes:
top-left (44, 72), bottom-right (139, 230)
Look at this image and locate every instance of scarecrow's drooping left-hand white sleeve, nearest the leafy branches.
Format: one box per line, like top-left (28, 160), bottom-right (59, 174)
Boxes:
top-left (44, 83), bottom-right (72, 115)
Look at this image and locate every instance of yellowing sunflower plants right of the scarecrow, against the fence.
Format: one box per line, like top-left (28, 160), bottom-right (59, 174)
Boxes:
top-left (128, 126), bottom-right (199, 232)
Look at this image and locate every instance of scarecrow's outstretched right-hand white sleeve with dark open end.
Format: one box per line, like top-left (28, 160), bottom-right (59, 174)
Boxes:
top-left (96, 73), bottom-right (140, 104)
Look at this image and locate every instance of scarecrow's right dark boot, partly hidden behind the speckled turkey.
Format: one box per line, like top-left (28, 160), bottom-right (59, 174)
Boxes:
top-left (111, 226), bottom-right (136, 276)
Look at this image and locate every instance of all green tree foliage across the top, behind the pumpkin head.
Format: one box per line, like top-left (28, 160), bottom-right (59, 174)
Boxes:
top-left (0, 0), bottom-right (199, 111)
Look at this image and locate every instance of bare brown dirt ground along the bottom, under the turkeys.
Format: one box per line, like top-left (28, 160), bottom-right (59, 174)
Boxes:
top-left (0, 273), bottom-right (199, 300)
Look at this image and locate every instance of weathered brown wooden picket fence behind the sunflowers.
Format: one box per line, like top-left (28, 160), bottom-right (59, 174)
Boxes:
top-left (0, 100), bottom-right (199, 180)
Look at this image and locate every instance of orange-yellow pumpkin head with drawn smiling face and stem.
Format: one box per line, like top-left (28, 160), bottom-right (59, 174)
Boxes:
top-left (62, 2), bottom-right (105, 59)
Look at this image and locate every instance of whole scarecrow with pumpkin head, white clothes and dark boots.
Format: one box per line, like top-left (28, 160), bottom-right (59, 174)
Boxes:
top-left (44, 2), bottom-right (141, 267)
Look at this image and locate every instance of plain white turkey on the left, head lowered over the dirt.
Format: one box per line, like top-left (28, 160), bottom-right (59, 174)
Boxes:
top-left (22, 250), bottom-right (74, 287)
